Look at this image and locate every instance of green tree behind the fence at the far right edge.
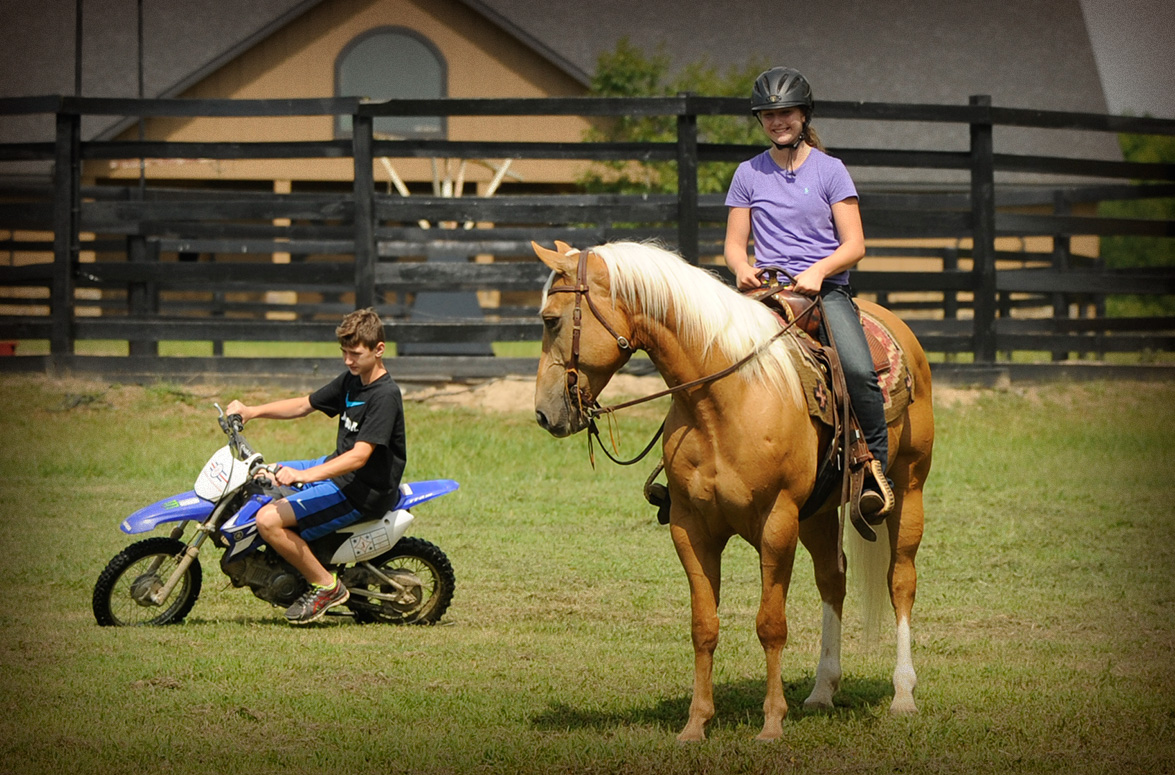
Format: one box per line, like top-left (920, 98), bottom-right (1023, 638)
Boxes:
top-left (1097, 135), bottom-right (1175, 316)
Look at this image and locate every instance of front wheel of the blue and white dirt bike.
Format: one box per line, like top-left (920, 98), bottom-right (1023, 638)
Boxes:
top-left (93, 537), bottom-right (202, 627)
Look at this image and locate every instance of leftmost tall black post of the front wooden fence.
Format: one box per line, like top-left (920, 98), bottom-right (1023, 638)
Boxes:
top-left (49, 113), bottom-right (81, 360)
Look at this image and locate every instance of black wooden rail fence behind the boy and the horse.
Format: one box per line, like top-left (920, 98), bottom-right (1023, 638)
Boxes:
top-left (0, 95), bottom-right (1175, 378)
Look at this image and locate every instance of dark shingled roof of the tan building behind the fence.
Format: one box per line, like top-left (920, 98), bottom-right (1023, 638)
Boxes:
top-left (0, 0), bottom-right (1121, 180)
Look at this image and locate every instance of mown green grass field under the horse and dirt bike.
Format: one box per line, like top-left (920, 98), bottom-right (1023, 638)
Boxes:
top-left (0, 377), bottom-right (1175, 775)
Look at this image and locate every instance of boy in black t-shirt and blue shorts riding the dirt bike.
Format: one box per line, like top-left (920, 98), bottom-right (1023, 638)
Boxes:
top-left (227, 308), bottom-right (408, 625)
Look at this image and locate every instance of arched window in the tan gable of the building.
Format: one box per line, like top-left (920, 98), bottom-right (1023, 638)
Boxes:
top-left (335, 27), bottom-right (448, 139)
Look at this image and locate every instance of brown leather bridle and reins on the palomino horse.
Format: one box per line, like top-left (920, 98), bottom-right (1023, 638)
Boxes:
top-left (546, 250), bottom-right (820, 466)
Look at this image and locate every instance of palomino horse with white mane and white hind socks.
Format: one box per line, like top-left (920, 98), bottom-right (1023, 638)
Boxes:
top-left (533, 243), bottom-right (934, 740)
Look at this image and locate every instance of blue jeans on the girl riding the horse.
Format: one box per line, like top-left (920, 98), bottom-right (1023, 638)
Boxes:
top-left (820, 283), bottom-right (889, 471)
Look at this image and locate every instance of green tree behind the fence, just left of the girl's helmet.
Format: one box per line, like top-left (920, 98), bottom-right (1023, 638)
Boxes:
top-left (579, 38), bottom-right (767, 194)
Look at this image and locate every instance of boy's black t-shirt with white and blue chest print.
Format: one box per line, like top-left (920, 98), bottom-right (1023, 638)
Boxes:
top-left (310, 371), bottom-right (408, 515)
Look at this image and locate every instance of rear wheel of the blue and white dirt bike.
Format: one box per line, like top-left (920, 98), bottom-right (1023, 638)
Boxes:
top-left (343, 537), bottom-right (457, 625)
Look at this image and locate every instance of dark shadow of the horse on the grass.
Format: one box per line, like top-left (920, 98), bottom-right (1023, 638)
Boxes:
top-left (530, 675), bottom-right (893, 732)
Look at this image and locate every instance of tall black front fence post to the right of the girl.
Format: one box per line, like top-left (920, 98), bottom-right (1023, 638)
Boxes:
top-left (971, 94), bottom-right (996, 363)
